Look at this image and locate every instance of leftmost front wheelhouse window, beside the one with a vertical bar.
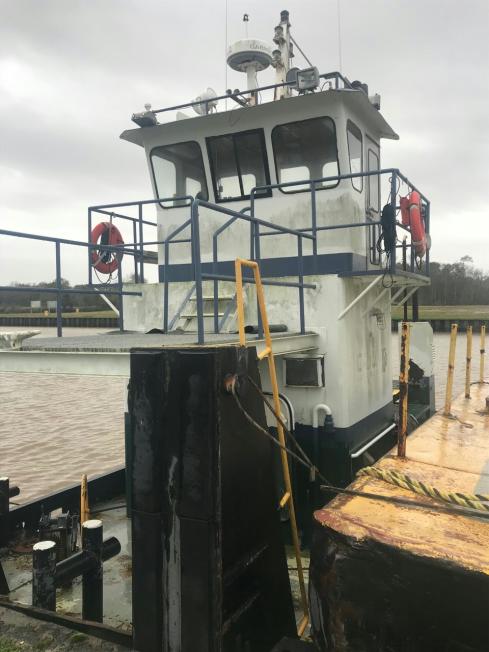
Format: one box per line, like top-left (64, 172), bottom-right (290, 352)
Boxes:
top-left (150, 141), bottom-right (209, 208)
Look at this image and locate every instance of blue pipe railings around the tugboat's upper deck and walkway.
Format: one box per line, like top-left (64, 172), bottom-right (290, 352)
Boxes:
top-left (0, 168), bottom-right (430, 343)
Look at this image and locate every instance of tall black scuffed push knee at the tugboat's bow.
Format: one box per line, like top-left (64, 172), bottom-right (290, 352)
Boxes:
top-left (129, 346), bottom-right (295, 652)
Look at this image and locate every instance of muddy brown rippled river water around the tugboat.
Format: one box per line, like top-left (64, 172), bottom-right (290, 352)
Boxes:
top-left (0, 327), bottom-right (479, 502)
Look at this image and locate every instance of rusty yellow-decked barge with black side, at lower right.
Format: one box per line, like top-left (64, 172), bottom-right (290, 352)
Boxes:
top-left (310, 385), bottom-right (489, 652)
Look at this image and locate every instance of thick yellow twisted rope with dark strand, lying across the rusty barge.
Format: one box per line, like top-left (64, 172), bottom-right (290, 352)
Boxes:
top-left (358, 466), bottom-right (489, 512)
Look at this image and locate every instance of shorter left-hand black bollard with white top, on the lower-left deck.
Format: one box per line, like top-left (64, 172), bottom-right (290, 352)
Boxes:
top-left (32, 541), bottom-right (56, 611)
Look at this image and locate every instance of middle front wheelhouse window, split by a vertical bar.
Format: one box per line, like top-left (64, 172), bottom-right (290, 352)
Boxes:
top-left (207, 129), bottom-right (272, 202)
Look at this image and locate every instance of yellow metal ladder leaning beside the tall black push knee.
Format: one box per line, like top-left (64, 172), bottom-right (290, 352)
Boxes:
top-left (235, 258), bottom-right (309, 636)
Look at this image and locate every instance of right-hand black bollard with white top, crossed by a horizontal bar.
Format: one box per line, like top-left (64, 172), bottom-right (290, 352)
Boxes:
top-left (82, 519), bottom-right (104, 623)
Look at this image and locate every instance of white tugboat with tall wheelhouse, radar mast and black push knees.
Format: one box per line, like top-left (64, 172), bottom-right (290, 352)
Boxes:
top-left (4, 11), bottom-right (472, 652)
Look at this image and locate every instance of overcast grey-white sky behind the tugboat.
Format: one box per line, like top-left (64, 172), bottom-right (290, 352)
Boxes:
top-left (0, 0), bottom-right (489, 283)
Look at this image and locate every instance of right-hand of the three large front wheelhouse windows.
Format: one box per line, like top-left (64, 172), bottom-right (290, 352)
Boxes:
top-left (272, 117), bottom-right (339, 192)
